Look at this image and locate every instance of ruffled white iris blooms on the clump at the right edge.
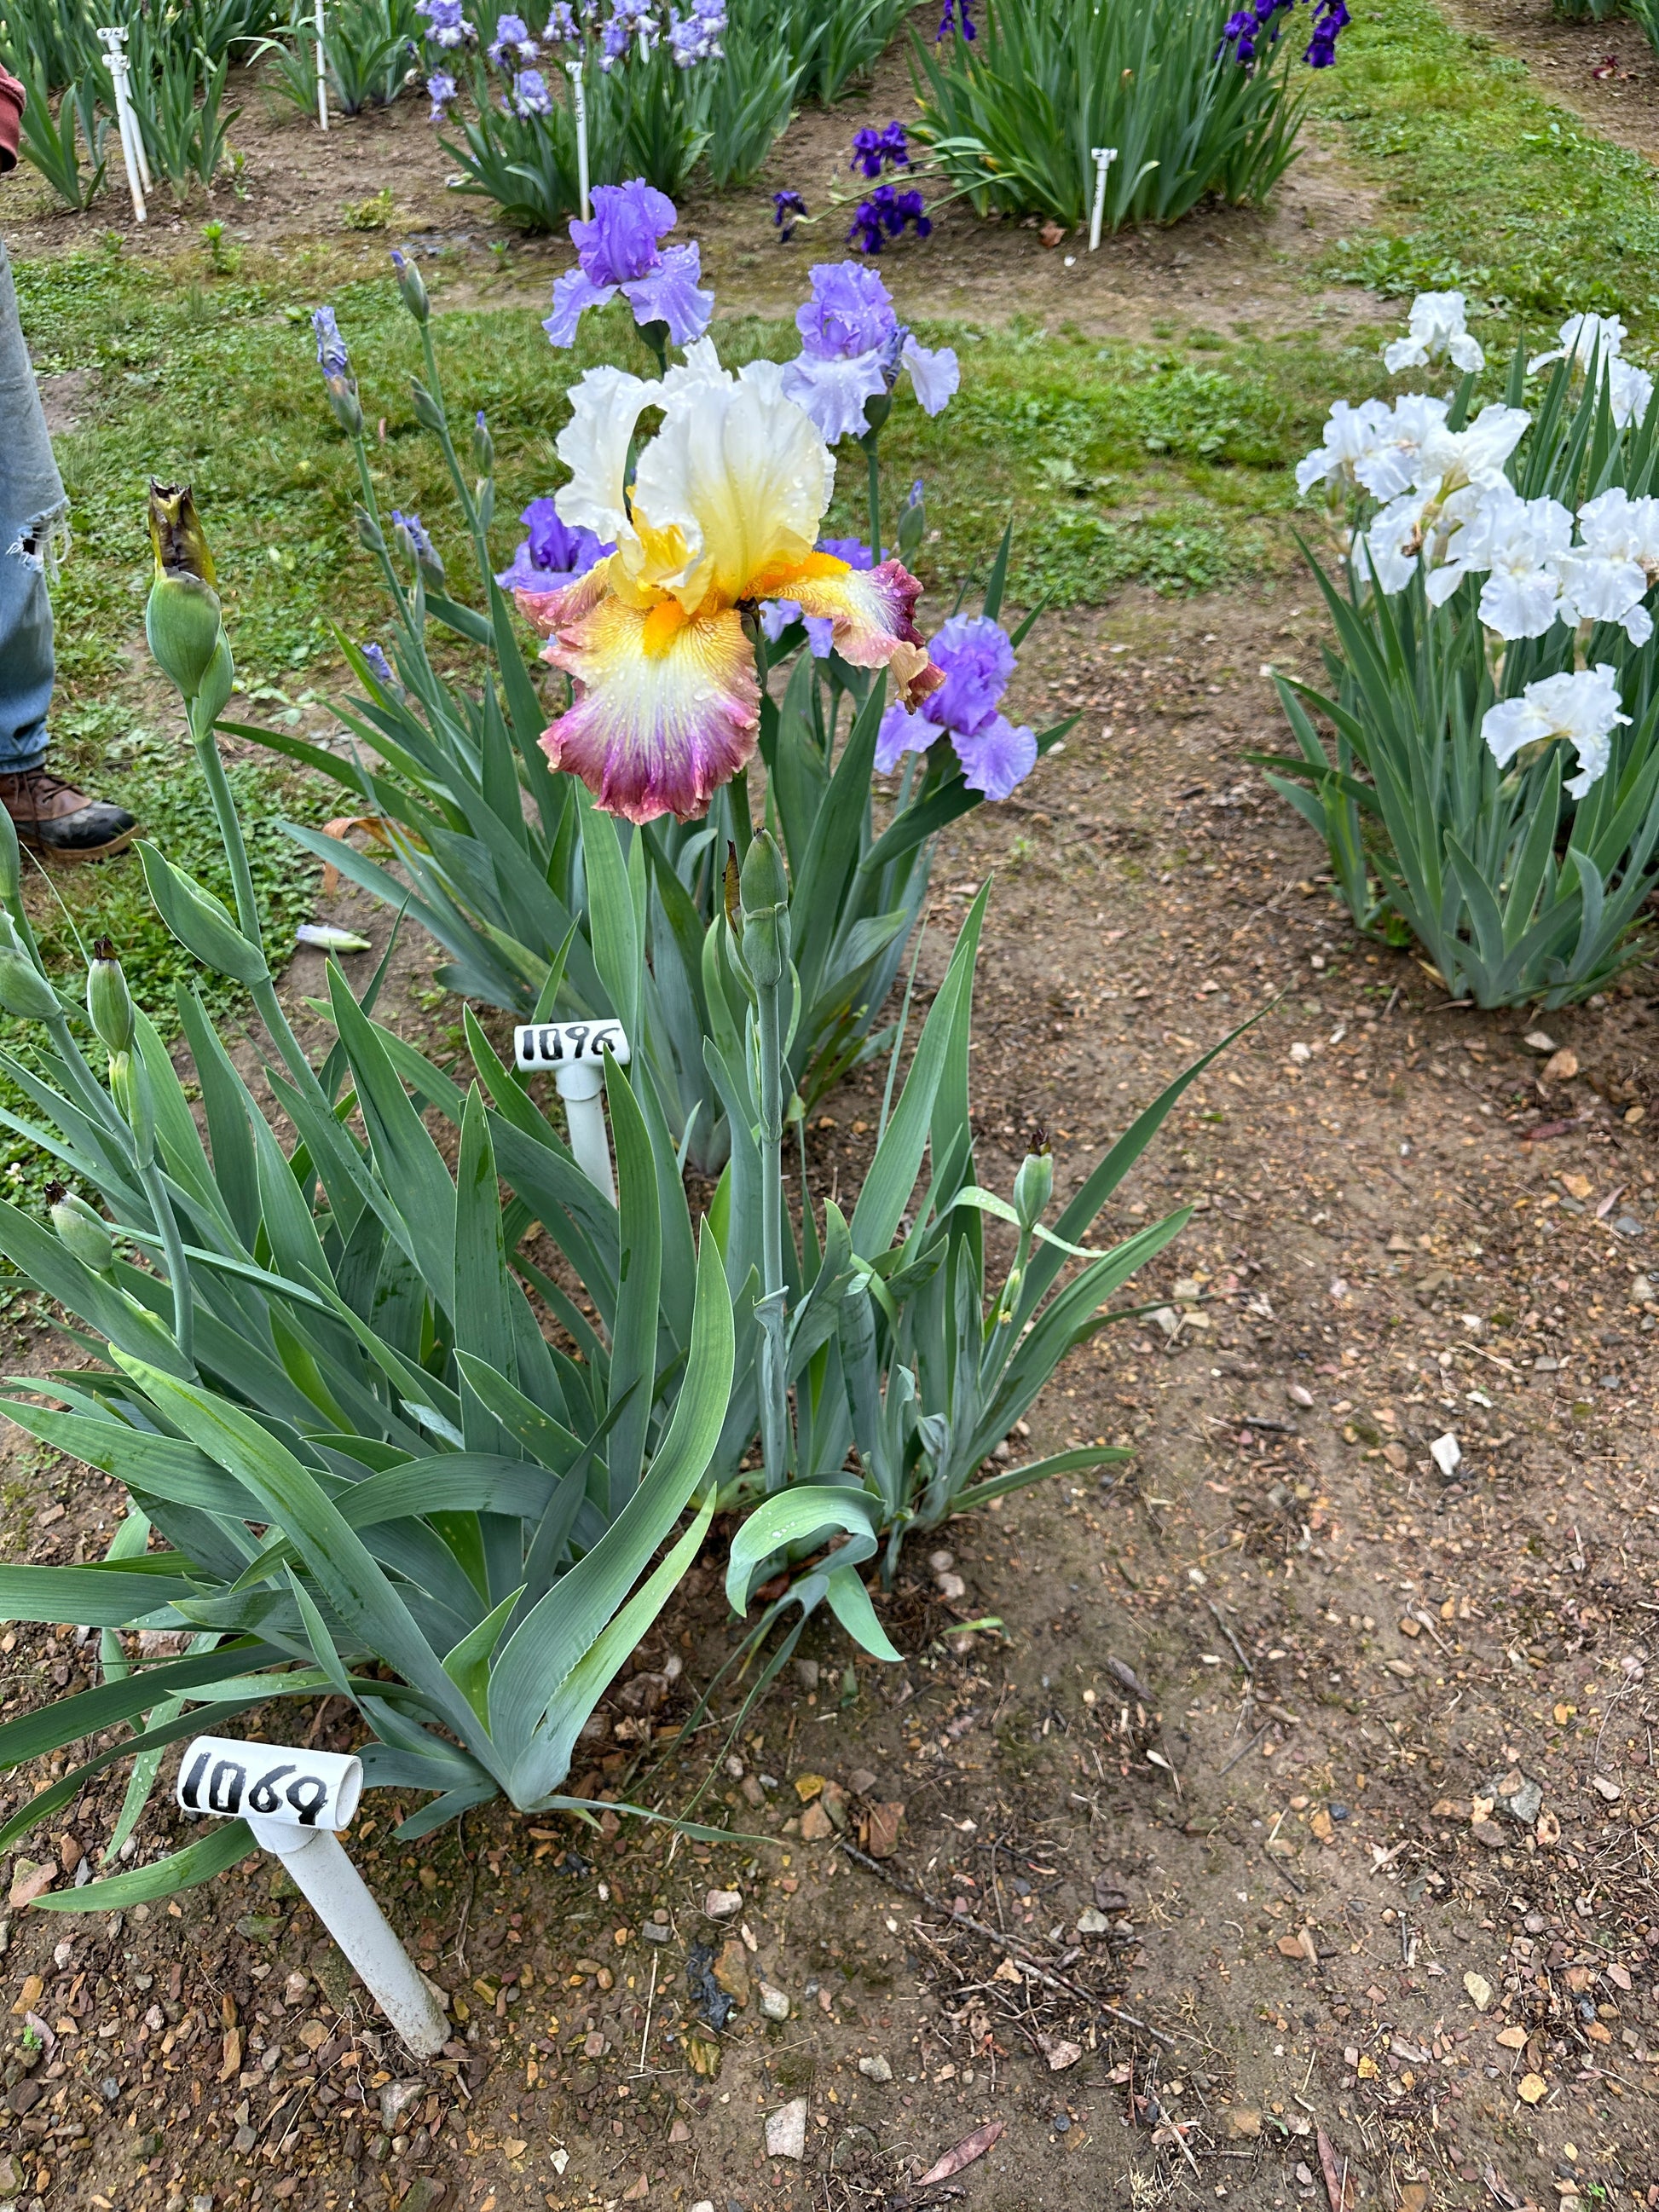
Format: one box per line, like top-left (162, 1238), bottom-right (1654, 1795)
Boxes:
top-left (1296, 292), bottom-right (1659, 799)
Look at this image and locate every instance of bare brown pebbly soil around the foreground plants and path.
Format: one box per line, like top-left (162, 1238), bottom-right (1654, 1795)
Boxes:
top-left (0, 591), bottom-right (1659, 2212)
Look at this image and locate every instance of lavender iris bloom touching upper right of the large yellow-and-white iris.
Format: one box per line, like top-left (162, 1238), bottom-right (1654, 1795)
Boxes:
top-left (783, 261), bottom-right (962, 445)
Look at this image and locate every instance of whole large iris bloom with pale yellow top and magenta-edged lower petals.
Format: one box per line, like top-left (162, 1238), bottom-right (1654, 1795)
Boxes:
top-left (516, 338), bottom-right (942, 823)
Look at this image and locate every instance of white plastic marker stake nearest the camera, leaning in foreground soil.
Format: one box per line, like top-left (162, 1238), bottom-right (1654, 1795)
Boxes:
top-left (177, 1736), bottom-right (449, 2059)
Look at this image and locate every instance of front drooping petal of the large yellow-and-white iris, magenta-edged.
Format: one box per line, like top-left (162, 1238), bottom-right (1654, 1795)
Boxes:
top-left (540, 592), bottom-right (761, 823)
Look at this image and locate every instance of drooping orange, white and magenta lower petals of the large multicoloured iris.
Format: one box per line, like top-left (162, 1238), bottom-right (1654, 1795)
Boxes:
top-left (516, 553), bottom-right (945, 823)
